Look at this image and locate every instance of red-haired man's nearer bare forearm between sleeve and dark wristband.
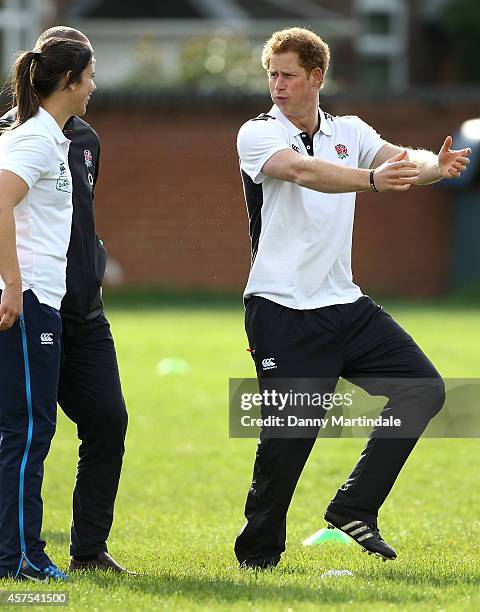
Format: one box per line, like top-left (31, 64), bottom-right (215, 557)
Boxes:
top-left (293, 158), bottom-right (370, 193)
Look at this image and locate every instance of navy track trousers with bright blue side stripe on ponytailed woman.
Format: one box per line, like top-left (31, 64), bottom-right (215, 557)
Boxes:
top-left (0, 290), bottom-right (62, 577)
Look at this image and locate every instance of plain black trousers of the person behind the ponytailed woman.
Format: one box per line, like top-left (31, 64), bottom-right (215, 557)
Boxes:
top-left (58, 313), bottom-right (127, 556)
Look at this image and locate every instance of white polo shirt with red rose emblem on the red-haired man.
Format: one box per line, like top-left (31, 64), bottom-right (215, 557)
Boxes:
top-left (237, 105), bottom-right (385, 310)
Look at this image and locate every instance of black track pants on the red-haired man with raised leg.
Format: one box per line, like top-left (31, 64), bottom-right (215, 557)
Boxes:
top-left (235, 296), bottom-right (445, 562)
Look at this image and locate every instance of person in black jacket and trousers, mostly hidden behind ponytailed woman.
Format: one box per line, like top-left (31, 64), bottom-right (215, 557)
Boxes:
top-left (0, 26), bottom-right (132, 573)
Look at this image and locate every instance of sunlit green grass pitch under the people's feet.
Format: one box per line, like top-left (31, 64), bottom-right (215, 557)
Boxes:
top-left (1, 304), bottom-right (480, 611)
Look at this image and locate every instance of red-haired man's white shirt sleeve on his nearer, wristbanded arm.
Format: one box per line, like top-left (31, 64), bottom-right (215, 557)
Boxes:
top-left (237, 118), bottom-right (290, 183)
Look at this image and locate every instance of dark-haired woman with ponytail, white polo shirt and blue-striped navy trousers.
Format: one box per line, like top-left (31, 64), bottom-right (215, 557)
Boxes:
top-left (0, 38), bottom-right (95, 581)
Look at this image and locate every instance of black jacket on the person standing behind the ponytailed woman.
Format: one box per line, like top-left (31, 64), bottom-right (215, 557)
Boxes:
top-left (0, 109), bottom-right (106, 321)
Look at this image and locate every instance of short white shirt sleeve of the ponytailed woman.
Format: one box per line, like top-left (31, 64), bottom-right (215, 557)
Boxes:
top-left (0, 130), bottom-right (52, 189)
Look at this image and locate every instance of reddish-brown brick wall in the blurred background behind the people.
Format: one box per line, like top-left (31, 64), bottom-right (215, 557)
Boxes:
top-left (87, 102), bottom-right (475, 296)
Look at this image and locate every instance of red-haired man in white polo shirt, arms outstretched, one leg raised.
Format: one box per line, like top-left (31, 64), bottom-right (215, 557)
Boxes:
top-left (235, 28), bottom-right (469, 568)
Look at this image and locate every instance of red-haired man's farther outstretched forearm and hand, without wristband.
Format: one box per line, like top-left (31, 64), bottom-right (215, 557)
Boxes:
top-left (371, 136), bottom-right (471, 185)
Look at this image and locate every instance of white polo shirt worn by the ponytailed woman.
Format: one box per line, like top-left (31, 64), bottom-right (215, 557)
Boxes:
top-left (0, 108), bottom-right (73, 310)
